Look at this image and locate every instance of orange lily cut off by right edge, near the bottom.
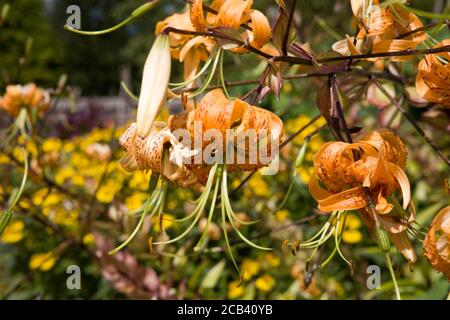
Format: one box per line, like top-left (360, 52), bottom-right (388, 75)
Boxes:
top-left (423, 206), bottom-right (450, 281)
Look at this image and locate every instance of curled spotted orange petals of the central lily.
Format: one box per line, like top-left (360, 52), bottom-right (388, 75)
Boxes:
top-left (184, 89), bottom-right (284, 171)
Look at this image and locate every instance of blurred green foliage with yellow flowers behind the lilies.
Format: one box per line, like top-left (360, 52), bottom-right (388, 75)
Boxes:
top-left (0, 0), bottom-right (450, 299)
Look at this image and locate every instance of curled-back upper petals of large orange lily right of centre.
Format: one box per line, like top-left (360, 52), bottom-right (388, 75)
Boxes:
top-left (309, 130), bottom-right (411, 214)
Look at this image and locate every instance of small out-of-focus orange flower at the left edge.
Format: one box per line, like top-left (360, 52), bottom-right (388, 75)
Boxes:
top-left (0, 83), bottom-right (50, 117)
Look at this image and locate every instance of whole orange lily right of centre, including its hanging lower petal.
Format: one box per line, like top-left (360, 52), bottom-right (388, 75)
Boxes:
top-left (309, 130), bottom-right (416, 262)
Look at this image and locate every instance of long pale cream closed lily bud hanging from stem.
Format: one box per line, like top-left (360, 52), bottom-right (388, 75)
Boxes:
top-left (137, 35), bottom-right (171, 138)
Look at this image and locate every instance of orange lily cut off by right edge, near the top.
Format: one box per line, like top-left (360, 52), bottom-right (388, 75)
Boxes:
top-left (416, 40), bottom-right (450, 108)
